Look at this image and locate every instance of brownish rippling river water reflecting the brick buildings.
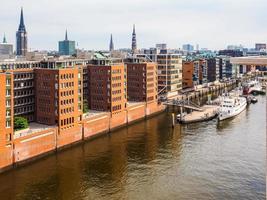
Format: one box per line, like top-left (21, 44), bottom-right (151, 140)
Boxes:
top-left (0, 97), bottom-right (266, 200)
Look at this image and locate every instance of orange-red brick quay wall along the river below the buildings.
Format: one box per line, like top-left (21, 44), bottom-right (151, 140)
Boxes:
top-left (0, 102), bottom-right (165, 172)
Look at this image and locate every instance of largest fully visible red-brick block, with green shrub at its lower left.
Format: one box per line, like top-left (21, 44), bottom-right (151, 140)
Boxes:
top-left (34, 61), bottom-right (83, 132)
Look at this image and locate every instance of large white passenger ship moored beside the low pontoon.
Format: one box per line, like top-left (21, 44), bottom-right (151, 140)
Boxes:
top-left (219, 96), bottom-right (247, 121)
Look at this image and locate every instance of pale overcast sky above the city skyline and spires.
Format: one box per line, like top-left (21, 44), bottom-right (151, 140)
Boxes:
top-left (0, 0), bottom-right (267, 50)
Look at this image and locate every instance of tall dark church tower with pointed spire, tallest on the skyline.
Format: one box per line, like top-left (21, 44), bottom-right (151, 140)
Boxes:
top-left (16, 8), bottom-right (28, 56)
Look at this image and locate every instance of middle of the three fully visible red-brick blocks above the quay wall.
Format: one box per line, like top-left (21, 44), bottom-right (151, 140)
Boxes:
top-left (87, 58), bottom-right (127, 114)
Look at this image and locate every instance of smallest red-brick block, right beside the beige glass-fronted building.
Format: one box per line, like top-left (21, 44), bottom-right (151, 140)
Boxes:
top-left (125, 58), bottom-right (158, 102)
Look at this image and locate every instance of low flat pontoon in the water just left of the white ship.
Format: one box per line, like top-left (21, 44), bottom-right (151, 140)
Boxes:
top-left (179, 105), bottom-right (219, 124)
